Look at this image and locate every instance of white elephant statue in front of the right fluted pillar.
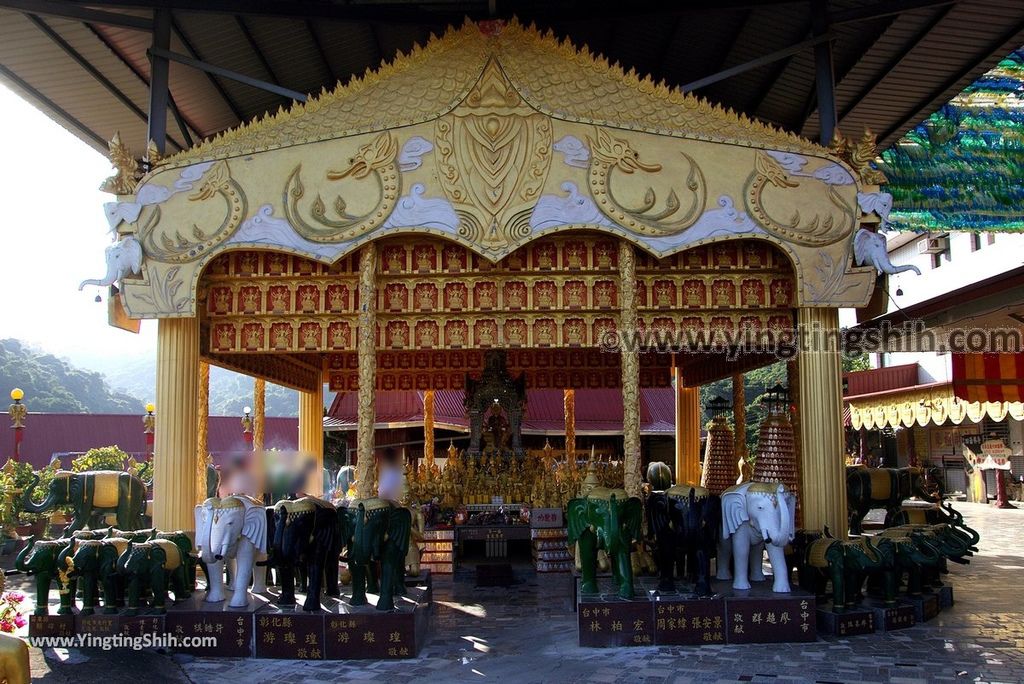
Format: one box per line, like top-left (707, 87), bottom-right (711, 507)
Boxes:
top-left (718, 482), bottom-right (797, 594)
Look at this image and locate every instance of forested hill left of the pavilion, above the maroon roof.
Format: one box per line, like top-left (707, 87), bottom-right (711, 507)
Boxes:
top-left (0, 339), bottom-right (144, 414)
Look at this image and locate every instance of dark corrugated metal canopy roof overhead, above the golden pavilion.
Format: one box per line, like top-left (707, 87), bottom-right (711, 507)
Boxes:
top-left (0, 0), bottom-right (1024, 154)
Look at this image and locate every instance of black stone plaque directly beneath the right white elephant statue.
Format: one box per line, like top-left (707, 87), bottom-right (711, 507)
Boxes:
top-left (725, 594), bottom-right (818, 644)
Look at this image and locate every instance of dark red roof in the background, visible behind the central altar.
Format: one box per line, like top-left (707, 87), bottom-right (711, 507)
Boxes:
top-left (328, 387), bottom-right (675, 434)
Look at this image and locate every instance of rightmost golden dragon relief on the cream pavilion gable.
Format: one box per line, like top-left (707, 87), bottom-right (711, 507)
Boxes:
top-left (745, 151), bottom-right (856, 247)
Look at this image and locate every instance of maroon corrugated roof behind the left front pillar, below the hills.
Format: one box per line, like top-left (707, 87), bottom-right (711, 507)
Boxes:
top-left (9, 414), bottom-right (299, 467)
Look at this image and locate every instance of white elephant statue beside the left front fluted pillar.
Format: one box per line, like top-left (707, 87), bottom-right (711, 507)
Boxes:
top-left (196, 495), bottom-right (266, 608)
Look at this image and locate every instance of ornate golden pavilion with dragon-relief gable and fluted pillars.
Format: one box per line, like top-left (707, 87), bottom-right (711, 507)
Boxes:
top-left (99, 23), bottom-right (879, 530)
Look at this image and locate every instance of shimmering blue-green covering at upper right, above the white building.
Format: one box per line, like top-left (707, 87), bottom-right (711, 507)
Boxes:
top-left (879, 48), bottom-right (1024, 230)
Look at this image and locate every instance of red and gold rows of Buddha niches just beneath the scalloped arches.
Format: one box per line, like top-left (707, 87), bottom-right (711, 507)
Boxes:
top-left (197, 234), bottom-right (794, 354)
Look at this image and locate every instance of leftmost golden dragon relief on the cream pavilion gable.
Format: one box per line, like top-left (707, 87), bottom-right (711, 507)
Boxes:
top-left (140, 162), bottom-right (247, 263)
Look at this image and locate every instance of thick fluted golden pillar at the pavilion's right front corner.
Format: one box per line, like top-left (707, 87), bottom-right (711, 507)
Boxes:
top-left (797, 307), bottom-right (847, 539)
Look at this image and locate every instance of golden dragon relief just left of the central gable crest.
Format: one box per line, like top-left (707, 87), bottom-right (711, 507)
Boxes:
top-left (283, 131), bottom-right (401, 243)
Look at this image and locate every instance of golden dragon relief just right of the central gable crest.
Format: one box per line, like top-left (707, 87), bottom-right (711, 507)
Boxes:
top-left (588, 128), bottom-right (708, 236)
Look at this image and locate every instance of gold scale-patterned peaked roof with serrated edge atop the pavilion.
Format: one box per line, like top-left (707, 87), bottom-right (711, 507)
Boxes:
top-left (161, 19), bottom-right (826, 167)
